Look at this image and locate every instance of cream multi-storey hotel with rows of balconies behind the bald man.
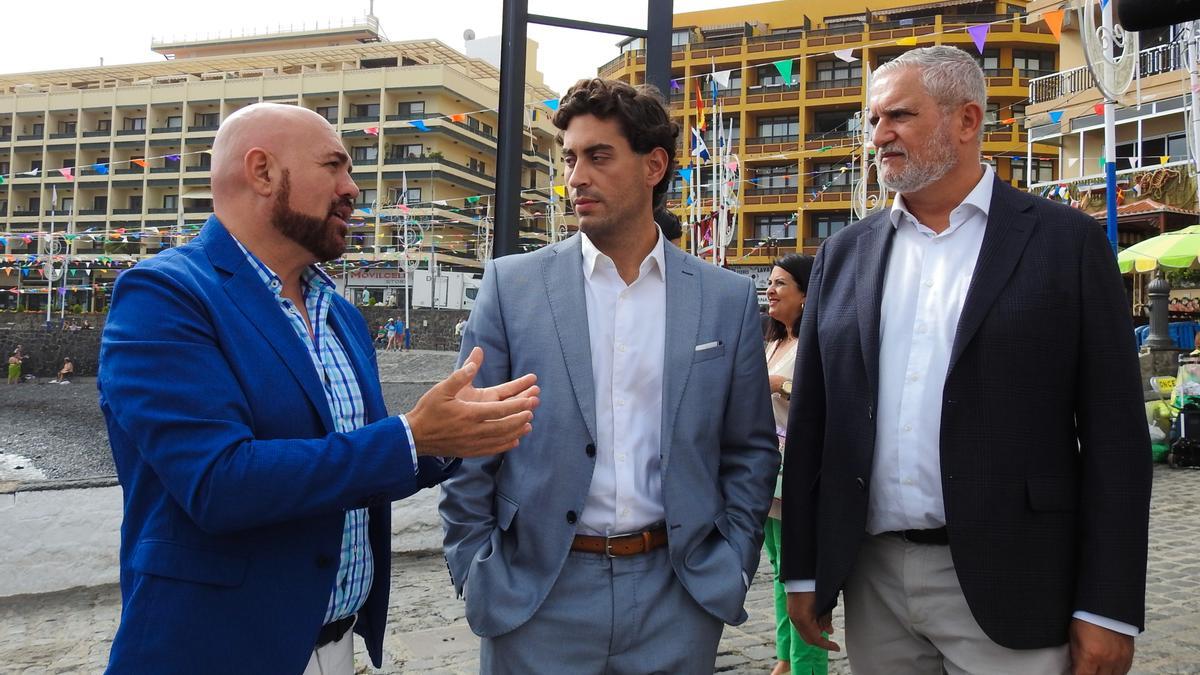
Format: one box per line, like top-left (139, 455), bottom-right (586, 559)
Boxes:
top-left (0, 16), bottom-right (558, 309)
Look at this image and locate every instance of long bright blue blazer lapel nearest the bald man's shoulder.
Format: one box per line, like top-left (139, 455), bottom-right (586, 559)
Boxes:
top-left (202, 216), bottom-right (334, 431)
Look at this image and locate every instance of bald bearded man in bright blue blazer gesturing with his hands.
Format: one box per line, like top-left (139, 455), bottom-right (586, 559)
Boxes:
top-left (98, 103), bottom-right (536, 675)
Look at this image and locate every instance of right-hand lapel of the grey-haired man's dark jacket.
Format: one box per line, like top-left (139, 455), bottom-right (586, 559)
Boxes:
top-left (949, 179), bottom-right (1037, 370)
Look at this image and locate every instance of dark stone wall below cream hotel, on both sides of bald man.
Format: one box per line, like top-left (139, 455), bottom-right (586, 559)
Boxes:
top-left (0, 305), bottom-right (469, 382)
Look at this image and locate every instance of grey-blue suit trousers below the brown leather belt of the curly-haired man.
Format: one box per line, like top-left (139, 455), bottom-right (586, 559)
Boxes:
top-left (479, 546), bottom-right (737, 675)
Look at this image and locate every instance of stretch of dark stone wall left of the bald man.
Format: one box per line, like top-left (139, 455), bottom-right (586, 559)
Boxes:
top-left (0, 312), bottom-right (106, 377)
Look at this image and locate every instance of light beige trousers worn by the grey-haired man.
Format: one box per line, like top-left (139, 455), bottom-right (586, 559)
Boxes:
top-left (845, 534), bottom-right (1070, 675)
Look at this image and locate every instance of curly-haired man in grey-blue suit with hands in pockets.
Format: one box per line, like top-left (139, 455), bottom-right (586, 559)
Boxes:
top-left (440, 79), bottom-right (780, 674)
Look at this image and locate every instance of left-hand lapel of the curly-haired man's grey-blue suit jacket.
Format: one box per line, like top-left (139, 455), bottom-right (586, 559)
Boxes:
top-left (541, 234), bottom-right (596, 442)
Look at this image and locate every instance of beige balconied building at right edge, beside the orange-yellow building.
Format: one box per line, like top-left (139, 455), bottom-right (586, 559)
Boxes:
top-left (1026, 0), bottom-right (1200, 246)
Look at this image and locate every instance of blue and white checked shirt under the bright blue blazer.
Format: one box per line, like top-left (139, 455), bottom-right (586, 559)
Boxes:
top-left (238, 241), bottom-right (376, 623)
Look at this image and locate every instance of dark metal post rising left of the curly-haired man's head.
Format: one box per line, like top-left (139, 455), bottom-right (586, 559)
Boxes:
top-left (492, 0), bottom-right (529, 258)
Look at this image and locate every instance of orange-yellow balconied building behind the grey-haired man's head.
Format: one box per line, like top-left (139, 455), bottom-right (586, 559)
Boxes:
top-left (600, 0), bottom-right (1058, 280)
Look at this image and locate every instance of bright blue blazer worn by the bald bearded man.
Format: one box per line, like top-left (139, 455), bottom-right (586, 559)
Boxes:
top-left (98, 216), bottom-right (456, 674)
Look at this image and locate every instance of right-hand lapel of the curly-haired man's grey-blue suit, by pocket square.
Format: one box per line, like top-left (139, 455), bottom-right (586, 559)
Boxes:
top-left (660, 245), bottom-right (700, 473)
